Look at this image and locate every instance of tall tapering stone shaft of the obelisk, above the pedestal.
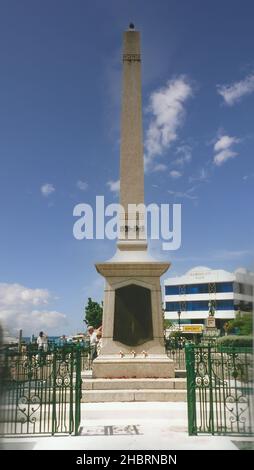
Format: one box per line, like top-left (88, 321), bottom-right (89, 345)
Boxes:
top-left (118, 29), bottom-right (147, 249)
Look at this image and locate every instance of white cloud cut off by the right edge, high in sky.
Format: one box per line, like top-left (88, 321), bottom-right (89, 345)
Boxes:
top-left (217, 74), bottom-right (254, 106)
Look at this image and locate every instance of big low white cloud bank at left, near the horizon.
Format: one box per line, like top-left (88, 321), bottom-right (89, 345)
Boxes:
top-left (0, 283), bottom-right (67, 335)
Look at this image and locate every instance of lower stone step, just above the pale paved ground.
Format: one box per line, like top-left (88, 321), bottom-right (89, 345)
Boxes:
top-left (81, 389), bottom-right (187, 403)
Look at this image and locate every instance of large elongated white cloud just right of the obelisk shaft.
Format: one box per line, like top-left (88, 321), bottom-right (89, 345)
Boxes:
top-left (145, 76), bottom-right (192, 171)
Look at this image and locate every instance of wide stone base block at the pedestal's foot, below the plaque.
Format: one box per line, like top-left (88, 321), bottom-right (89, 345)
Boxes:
top-left (93, 355), bottom-right (175, 379)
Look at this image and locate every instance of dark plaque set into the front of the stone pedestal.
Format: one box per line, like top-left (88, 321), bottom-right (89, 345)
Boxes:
top-left (113, 284), bottom-right (153, 346)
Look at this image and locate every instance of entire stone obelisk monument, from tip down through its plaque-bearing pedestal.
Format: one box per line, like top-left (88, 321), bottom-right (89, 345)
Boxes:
top-left (93, 24), bottom-right (174, 378)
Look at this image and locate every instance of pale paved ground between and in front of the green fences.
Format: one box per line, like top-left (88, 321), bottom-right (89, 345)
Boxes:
top-left (0, 402), bottom-right (253, 450)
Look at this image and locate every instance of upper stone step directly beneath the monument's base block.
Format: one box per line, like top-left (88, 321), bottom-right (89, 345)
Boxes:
top-left (82, 378), bottom-right (186, 391)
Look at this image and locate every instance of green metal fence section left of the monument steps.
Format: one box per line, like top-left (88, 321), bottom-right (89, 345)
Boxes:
top-left (0, 347), bottom-right (81, 436)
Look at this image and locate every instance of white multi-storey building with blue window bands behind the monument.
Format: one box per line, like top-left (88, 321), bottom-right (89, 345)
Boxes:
top-left (164, 266), bottom-right (254, 330)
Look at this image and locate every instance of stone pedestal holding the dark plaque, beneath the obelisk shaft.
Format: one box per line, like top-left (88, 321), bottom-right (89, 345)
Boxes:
top-left (93, 254), bottom-right (174, 378)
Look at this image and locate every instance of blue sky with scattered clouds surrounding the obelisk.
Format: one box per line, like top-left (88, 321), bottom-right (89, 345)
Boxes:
top-left (0, 0), bottom-right (254, 334)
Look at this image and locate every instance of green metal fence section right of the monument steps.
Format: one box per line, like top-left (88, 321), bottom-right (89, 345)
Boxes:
top-left (185, 344), bottom-right (254, 436)
